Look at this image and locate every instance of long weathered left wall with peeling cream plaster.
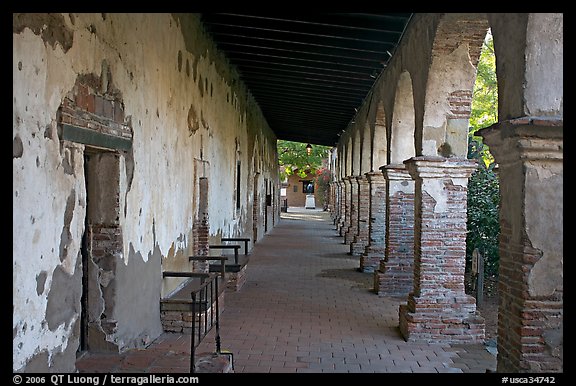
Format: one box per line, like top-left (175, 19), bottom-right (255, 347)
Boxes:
top-left (13, 14), bottom-right (278, 372)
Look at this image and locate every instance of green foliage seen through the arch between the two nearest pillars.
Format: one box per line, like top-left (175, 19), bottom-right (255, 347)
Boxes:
top-left (466, 30), bottom-right (500, 275)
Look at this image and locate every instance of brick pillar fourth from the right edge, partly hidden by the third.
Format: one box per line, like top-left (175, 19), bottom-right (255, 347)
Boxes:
top-left (360, 172), bottom-right (386, 272)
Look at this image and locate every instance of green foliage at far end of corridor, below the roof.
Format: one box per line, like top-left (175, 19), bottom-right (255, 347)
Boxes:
top-left (277, 140), bottom-right (330, 180)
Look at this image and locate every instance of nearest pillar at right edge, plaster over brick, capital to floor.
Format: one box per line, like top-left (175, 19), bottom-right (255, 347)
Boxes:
top-left (481, 118), bottom-right (564, 373)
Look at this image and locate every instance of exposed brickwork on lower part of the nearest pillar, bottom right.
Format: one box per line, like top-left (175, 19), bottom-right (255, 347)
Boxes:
top-left (498, 237), bottom-right (564, 372)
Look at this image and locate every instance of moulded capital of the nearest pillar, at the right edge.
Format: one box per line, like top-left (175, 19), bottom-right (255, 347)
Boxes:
top-left (478, 117), bottom-right (564, 165)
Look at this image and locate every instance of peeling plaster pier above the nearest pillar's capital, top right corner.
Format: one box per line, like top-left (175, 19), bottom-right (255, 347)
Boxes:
top-left (488, 13), bottom-right (564, 121)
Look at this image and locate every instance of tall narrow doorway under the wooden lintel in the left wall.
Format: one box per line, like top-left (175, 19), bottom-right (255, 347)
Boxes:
top-left (78, 147), bottom-right (122, 354)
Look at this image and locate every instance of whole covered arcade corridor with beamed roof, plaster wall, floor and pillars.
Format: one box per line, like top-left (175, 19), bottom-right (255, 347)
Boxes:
top-left (12, 13), bottom-right (564, 373)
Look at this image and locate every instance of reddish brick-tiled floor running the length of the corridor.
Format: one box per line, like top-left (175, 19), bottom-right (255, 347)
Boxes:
top-left (77, 208), bottom-right (496, 373)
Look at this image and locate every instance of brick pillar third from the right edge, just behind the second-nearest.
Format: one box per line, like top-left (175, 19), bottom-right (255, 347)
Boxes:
top-left (374, 164), bottom-right (414, 298)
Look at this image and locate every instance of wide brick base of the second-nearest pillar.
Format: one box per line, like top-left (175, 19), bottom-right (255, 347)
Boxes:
top-left (399, 295), bottom-right (486, 343)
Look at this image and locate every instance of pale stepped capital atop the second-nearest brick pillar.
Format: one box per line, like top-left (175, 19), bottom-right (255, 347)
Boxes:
top-left (404, 156), bottom-right (477, 179)
